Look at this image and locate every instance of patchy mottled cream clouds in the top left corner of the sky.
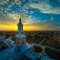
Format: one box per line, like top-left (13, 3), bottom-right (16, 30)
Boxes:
top-left (0, 0), bottom-right (22, 13)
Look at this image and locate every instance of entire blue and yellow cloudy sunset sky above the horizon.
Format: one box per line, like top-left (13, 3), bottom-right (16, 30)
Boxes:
top-left (0, 0), bottom-right (60, 31)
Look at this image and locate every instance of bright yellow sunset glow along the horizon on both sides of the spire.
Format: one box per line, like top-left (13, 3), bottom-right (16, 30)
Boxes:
top-left (0, 24), bottom-right (46, 31)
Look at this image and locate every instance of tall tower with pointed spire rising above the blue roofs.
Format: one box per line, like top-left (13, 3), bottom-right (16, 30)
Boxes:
top-left (16, 17), bottom-right (26, 48)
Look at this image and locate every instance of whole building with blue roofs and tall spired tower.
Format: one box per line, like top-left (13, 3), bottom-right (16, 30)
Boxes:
top-left (0, 18), bottom-right (53, 60)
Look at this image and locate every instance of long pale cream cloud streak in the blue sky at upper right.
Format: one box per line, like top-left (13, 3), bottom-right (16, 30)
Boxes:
top-left (30, 2), bottom-right (60, 14)
